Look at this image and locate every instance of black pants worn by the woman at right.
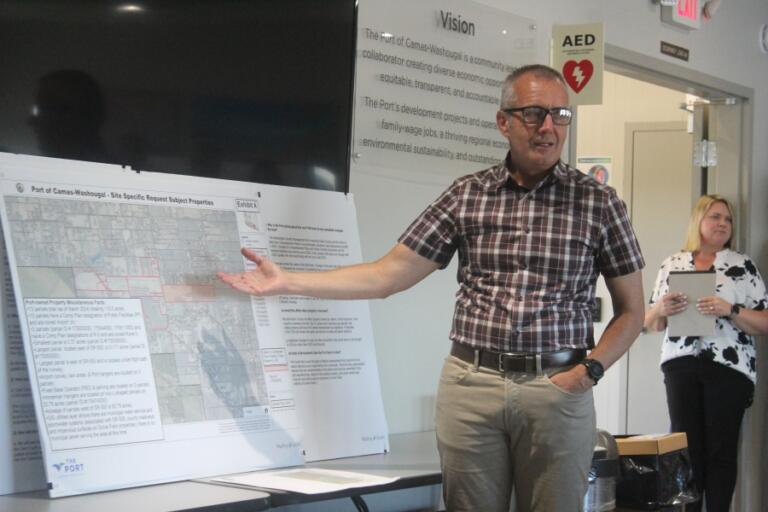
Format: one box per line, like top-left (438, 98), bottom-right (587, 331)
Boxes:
top-left (662, 356), bottom-right (754, 512)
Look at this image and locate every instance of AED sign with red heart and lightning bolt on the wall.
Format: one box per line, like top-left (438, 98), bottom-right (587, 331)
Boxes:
top-left (551, 23), bottom-right (605, 105)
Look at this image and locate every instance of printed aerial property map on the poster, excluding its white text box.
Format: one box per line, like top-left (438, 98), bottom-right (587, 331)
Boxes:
top-left (6, 197), bottom-right (268, 424)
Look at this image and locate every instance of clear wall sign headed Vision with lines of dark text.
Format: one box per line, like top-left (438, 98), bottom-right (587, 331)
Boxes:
top-left (353, 0), bottom-right (536, 176)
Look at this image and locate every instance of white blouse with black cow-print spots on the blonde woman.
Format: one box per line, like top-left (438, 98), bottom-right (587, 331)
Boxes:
top-left (650, 249), bottom-right (768, 382)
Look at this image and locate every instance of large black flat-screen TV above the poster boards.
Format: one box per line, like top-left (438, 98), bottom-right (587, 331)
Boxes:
top-left (0, 0), bottom-right (356, 192)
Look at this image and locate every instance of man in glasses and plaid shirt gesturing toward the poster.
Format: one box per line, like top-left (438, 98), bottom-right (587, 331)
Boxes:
top-left (220, 65), bottom-right (644, 512)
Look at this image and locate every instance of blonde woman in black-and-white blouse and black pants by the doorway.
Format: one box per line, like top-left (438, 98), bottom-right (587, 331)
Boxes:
top-left (645, 195), bottom-right (768, 512)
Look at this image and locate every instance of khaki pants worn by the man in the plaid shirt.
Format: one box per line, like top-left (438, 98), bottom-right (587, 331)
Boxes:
top-left (435, 356), bottom-right (596, 512)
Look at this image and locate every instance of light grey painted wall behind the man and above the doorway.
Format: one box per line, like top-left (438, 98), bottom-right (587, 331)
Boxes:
top-left (351, 0), bottom-right (768, 510)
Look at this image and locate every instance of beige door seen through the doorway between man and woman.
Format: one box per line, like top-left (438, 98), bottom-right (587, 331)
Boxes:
top-left (625, 122), bottom-right (694, 434)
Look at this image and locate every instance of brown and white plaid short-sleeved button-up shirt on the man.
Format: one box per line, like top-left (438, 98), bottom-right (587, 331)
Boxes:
top-left (399, 160), bottom-right (644, 352)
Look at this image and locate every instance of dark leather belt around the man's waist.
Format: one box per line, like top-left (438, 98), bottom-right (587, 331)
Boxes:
top-left (451, 341), bottom-right (587, 373)
